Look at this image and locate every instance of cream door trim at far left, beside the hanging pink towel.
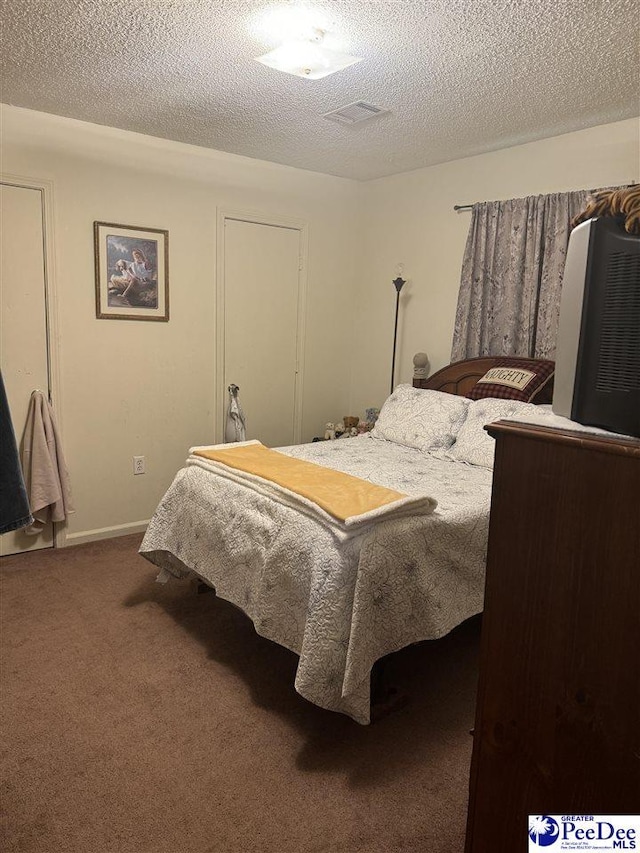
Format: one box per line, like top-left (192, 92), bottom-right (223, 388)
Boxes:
top-left (0, 171), bottom-right (66, 548)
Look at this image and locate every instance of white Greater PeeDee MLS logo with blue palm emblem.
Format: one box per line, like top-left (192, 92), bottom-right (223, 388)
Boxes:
top-left (529, 815), bottom-right (640, 853)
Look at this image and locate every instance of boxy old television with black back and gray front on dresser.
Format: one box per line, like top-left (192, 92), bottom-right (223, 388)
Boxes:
top-left (552, 216), bottom-right (640, 436)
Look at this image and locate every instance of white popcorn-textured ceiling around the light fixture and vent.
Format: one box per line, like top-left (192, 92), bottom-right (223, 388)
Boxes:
top-left (0, 0), bottom-right (640, 180)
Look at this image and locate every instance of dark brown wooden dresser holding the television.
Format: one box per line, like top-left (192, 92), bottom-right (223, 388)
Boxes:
top-left (465, 422), bottom-right (640, 853)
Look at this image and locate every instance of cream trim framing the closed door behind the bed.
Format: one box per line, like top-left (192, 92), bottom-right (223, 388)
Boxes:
top-left (213, 208), bottom-right (309, 444)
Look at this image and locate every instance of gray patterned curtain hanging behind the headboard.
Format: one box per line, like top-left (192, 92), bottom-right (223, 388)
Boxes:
top-left (451, 190), bottom-right (591, 361)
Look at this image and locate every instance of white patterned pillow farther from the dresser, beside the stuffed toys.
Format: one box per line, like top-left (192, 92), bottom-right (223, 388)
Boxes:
top-left (371, 385), bottom-right (471, 451)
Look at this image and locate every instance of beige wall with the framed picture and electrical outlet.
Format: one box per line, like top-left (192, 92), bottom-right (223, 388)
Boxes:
top-left (2, 107), bottom-right (359, 544)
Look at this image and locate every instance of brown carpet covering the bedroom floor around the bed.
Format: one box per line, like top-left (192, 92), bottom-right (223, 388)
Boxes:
top-left (0, 536), bottom-right (479, 853)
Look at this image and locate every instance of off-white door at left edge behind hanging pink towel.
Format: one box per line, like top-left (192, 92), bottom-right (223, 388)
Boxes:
top-left (0, 184), bottom-right (53, 555)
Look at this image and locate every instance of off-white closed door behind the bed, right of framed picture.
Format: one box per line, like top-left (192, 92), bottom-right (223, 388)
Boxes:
top-left (223, 217), bottom-right (302, 447)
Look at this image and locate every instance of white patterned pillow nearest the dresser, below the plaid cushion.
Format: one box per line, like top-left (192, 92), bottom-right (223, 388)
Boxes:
top-left (447, 398), bottom-right (539, 468)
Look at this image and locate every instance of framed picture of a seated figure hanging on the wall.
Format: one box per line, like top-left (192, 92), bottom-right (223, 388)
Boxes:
top-left (93, 222), bottom-right (169, 323)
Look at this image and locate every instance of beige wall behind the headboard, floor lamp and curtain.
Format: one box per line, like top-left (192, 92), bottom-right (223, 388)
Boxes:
top-left (351, 119), bottom-right (640, 411)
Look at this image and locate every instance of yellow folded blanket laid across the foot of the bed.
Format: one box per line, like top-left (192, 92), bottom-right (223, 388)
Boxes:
top-left (192, 443), bottom-right (410, 522)
